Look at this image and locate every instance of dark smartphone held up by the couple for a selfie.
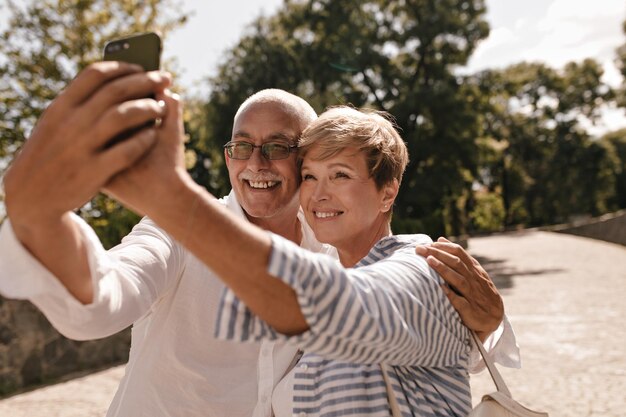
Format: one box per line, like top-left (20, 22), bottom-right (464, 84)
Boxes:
top-left (104, 32), bottom-right (161, 148)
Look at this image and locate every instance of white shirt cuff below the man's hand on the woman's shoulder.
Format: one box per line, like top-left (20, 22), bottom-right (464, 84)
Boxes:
top-left (469, 315), bottom-right (522, 374)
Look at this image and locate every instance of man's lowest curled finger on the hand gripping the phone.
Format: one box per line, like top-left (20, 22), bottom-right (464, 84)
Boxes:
top-left (98, 128), bottom-right (157, 179)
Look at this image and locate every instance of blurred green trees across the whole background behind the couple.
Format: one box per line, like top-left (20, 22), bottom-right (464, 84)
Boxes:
top-left (0, 0), bottom-right (626, 247)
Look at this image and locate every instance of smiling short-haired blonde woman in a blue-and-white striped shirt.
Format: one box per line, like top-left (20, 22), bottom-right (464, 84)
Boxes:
top-left (210, 107), bottom-right (471, 417)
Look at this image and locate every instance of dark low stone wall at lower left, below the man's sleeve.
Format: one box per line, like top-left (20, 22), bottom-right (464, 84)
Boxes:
top-left (0, 297), bottom-right (130, 397)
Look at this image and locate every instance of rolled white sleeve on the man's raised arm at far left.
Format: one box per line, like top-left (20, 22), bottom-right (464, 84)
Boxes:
top-left (0, 215), bottom-right (184, 340)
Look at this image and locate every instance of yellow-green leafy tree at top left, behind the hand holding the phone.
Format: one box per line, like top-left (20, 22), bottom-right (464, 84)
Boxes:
top-left (0, 0), bottom-right (186, 245)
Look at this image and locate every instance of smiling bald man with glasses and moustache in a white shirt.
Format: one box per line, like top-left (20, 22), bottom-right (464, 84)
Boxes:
top-left (0, 62), bottom-right (517, 416)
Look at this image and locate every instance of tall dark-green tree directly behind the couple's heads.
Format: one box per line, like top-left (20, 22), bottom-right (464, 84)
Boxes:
top-left (202, 0), bottom-right (489, 234)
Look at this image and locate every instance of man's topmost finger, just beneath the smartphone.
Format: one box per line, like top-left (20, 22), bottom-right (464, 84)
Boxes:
top-left (59, 61), bottom-right (143, 106)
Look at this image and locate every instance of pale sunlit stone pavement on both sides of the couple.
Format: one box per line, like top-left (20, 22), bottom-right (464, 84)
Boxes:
top-left (0, 231), bottom-right (626, 417)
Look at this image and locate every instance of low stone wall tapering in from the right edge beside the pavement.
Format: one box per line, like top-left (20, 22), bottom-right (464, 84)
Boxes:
top-left (548, 210), bottom-right (626, 246)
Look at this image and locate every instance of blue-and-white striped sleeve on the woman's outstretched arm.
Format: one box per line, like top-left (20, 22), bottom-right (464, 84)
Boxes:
top-left (216, 235), bottom-right (470, 366)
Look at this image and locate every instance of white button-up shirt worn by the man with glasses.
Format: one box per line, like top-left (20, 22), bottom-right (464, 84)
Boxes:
top-left (0, 192), bottom-right (330, 417)
